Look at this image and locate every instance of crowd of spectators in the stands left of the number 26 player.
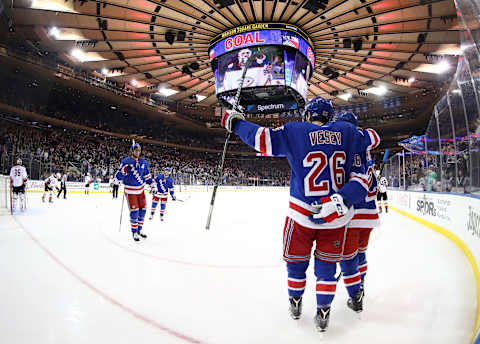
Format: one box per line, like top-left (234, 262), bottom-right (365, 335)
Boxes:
top-left (0, 115), bottom-right (289, 185)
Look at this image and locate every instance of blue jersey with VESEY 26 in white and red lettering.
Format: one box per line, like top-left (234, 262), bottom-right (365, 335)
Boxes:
top-left (234, 121), bottom-right (368, 229)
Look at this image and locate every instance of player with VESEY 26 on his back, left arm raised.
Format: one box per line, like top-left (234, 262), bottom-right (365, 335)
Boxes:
top-left (222, 97), bottom-right (368, 332)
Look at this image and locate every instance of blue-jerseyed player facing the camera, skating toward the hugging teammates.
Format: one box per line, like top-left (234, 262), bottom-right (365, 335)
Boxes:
top-left (115, 143), bottom-right (156, 241)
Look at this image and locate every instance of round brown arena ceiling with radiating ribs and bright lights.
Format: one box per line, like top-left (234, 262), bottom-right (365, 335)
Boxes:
top-left (5, 0), bottom-right (461, 105)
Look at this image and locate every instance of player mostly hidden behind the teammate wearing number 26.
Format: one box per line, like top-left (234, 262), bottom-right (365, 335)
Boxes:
top-left (337, 112), bottom-right (380, 306)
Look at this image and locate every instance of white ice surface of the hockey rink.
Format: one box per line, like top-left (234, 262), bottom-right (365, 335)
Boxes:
top-left (0, 191), bottom-right (476, 344)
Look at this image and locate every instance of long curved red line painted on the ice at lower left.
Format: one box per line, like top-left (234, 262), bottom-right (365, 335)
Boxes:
top-left (13, 216), bottom-right (203, 344)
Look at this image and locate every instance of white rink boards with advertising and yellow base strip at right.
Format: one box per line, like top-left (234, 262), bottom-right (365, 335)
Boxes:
top-left (388, 190), bottom-right (480, 344)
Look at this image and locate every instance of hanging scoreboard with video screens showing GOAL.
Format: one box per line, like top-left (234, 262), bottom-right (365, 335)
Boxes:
top-left (209, 24), bottom-right (315, 112)
